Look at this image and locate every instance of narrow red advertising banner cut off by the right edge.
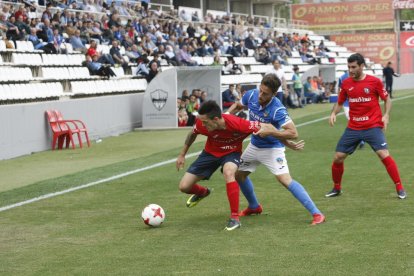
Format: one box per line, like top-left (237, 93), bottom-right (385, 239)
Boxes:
top-left (400, 32), bottom-right (414, 74)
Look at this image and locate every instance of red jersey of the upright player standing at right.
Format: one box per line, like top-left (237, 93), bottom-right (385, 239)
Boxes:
top-left (338, 75), bottom-right (388, 130)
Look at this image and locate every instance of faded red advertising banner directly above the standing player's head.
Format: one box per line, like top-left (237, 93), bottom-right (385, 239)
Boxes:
top-left (330, 33), bottom-right (397, 65)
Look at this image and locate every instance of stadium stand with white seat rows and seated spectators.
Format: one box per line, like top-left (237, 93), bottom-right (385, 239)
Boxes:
top-left (0, 1), bottom-right (382, 104)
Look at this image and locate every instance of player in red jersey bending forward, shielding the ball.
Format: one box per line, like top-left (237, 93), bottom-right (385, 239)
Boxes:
top-left (176, 101), bottom-right (274, 231)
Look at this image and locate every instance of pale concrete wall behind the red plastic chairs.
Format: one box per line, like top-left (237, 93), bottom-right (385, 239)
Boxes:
top-left (0, 93), bottom-right (144, 160)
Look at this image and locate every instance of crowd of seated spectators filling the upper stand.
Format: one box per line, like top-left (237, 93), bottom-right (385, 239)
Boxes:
top-left (0, 0), bottom-right (332, 79)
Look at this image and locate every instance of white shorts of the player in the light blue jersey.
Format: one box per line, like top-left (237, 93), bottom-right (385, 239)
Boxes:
top-left (239, 143), bottom-right (289, 175)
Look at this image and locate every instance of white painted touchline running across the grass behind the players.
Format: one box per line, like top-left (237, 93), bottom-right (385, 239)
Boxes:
top-left (0, 95), bottom-right (414, 212)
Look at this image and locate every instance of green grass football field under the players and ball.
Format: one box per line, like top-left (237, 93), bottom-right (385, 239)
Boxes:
top-left (0, 91), bottom-right (414, 275)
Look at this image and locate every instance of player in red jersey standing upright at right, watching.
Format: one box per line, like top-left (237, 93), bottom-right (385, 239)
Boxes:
top-left (325, 54), bottom-right (407, 199)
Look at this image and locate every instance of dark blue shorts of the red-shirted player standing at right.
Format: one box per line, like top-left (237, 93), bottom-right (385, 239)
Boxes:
top-left (336, 127), bottom-right (388, 154)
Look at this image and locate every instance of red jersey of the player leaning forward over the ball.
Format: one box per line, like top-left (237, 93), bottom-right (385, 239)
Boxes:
top-left (193, 114), bottom-right (260, 157)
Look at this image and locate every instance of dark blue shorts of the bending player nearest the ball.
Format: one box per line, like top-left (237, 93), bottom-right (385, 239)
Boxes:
top-left (187, 150), bottom-right (241, 179)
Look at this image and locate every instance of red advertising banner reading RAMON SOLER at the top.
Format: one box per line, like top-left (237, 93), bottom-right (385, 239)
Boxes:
top-left (291, 0), bottom-right (394, 31)
